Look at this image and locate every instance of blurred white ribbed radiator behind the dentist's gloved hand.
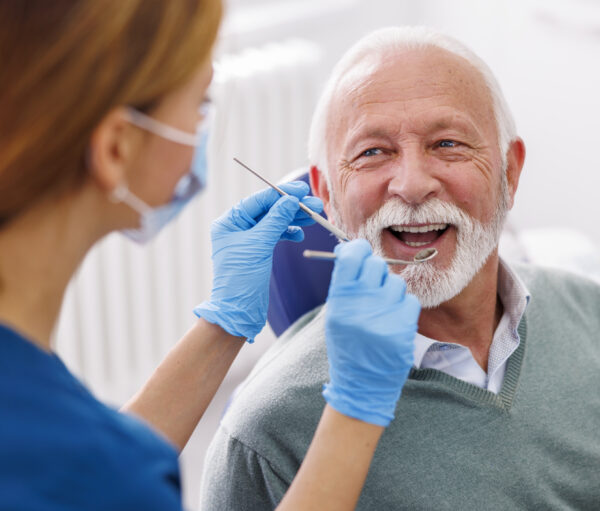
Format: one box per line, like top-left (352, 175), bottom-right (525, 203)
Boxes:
top-left (55, 40), bottom-right (323, 405)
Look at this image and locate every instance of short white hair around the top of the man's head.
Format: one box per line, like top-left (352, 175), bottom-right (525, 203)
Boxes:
top-left (308, 27), bottom-right (517, 184)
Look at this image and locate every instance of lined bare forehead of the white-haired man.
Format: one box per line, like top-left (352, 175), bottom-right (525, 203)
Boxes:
top-left (328, 47), bottom-right (497, 143)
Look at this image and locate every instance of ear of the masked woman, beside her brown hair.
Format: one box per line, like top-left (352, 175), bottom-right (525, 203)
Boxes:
top-left (88, 107), bottom-right (140, 192)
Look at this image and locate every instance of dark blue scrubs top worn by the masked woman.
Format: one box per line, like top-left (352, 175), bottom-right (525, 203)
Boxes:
top-left (0, 325), bottom-right (182, 511)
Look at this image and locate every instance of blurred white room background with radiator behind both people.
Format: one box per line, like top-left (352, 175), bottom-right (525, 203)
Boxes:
top-left (55, 0), bottom-right (600, 509)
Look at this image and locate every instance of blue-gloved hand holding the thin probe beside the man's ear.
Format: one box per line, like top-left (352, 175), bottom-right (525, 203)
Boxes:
top-left (194, 181), bottom-right (323, 342)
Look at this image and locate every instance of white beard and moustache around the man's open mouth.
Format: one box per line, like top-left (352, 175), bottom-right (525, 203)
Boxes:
top-left (332, 172), bottom-right (509, 308)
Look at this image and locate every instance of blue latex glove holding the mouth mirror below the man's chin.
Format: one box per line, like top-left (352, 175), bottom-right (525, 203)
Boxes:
top-left (323, 240), bottom-right (421, 426)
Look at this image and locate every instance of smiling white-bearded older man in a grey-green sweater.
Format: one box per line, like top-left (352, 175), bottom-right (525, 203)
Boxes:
top-left (201, 28), bottom-right (600, 511)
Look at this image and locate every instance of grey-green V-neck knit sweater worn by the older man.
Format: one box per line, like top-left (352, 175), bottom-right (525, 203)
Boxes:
top-left (201, 267), bottom-right (600, 511)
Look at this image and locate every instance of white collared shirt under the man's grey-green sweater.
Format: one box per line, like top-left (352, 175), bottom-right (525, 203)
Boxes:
top-left (414, 259), bottom-right (530, 394)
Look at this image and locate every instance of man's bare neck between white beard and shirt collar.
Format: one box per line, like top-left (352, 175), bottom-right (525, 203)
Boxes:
top-left (419, 255), bottom-right (503, 371)
